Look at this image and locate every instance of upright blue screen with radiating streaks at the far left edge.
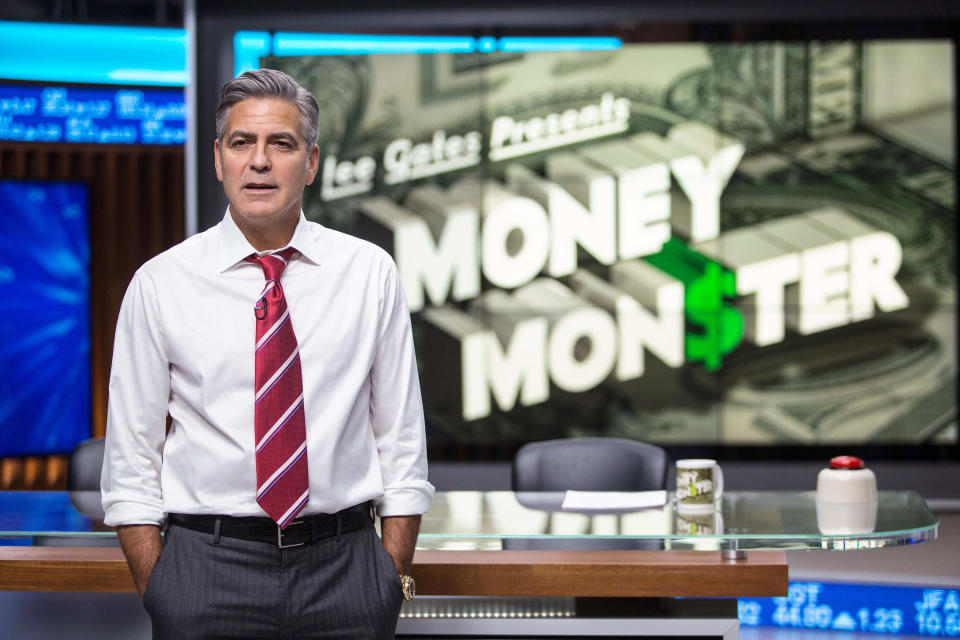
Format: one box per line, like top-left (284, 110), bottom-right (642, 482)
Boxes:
top-left (0, 180), bottom-right (91, 457)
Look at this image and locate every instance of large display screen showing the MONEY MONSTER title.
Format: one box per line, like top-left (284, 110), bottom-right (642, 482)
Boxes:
top-left (246, 34), bottom-right (957, 447)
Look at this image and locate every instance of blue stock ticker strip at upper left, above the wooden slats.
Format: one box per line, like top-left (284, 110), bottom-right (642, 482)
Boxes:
top-left (0, 84), bottom-right (187, 145)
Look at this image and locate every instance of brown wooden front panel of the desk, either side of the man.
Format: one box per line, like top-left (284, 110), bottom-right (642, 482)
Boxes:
top-left (0, 547), bottom-right (787, 597)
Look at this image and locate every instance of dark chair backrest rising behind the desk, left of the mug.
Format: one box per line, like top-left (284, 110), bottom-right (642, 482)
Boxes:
top-left (512, 438), bottom-right (669, 491)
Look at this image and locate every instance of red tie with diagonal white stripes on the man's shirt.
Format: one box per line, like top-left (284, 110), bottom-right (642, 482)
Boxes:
top-left (247, 248), bottom-right (309, 529)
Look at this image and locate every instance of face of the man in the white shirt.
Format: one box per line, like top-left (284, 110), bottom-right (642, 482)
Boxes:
top-left (214, 98), bottom-right (320, 229)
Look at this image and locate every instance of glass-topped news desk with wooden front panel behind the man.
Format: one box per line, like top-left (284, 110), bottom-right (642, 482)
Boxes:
top-left (0, 491), bottom-right (938, 638)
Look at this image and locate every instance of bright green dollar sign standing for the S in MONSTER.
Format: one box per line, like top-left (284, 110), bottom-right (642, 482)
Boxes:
top-left (685, 262), bottom-right (743, 371)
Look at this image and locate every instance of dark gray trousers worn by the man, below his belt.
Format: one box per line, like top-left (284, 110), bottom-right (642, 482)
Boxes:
top-left (143, 525), bottom-right (403, 640)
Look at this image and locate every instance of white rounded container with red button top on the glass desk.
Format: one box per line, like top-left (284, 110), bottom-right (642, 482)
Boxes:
top-left (816, 456), bottom-right (877, 535)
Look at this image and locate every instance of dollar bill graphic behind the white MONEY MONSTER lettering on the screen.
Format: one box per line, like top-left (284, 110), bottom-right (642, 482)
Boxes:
top-left (262, 41), bottom-right (958, 456)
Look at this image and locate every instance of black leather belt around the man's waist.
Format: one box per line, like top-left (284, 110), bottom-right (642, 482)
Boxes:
top-left (167, 503), bottom-right (373, 549)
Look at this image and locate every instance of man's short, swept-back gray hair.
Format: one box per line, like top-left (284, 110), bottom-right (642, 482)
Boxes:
top-left (216, 69), bottom-right (320, 146)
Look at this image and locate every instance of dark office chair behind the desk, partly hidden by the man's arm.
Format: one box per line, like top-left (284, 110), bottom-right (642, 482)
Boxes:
top-left (33, 438), bottom-right (120, 547)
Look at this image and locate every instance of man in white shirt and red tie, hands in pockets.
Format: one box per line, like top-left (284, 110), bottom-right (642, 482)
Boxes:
top-left (102, 69), bottom-right (433, 639)
